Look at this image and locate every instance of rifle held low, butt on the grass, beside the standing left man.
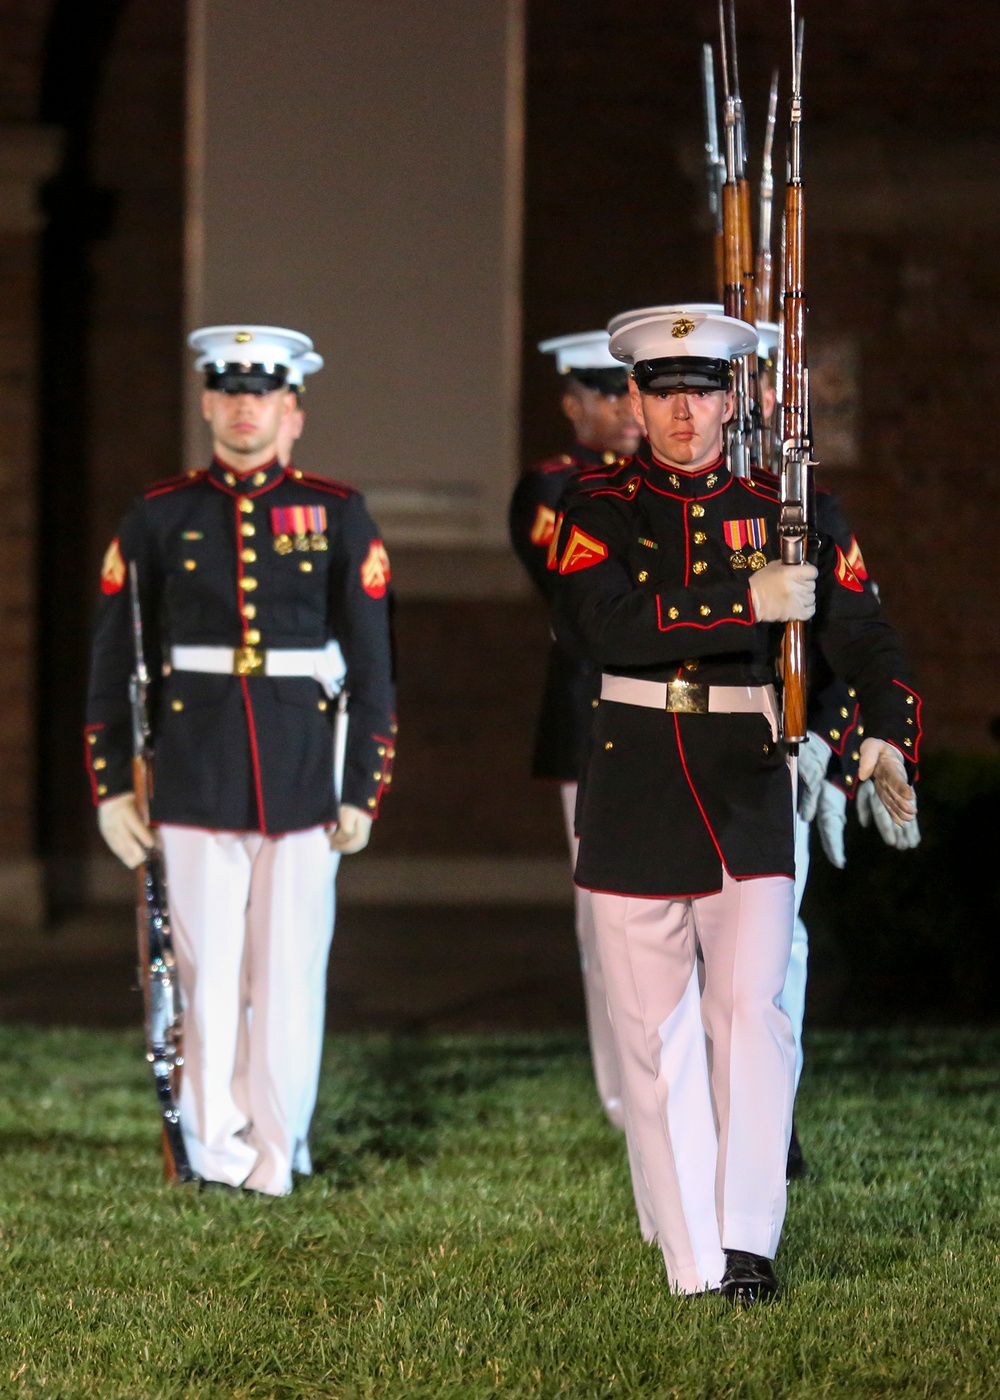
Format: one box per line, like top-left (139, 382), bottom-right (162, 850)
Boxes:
top-left (129, 560), bottom-right (195, 1182)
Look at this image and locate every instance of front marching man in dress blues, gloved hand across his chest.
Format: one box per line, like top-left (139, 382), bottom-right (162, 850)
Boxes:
top-left (553, 308), bottom-right (920, 1296)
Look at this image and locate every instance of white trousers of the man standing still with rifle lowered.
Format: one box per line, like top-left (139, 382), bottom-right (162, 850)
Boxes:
top-left (160, 826), bottom-right (340, 1196)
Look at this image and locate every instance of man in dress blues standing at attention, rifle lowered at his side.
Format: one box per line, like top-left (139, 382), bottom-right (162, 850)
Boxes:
top-left (85, 326), bottom-right (396, 1194)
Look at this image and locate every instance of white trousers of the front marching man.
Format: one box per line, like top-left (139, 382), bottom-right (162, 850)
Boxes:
top-left (591, 874), bottom-right (796, 1292)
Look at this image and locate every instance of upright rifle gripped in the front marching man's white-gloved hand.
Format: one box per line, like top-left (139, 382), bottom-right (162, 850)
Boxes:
top-left (777, 8), bottom-right (815, 753)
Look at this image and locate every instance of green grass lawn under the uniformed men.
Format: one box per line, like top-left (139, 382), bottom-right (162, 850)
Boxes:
top-left (0, 1028), bottom-right (1000, 1400)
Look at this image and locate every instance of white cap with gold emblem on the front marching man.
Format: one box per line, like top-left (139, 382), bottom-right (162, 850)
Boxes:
top-left (608, 304), bottom-right (758, 392)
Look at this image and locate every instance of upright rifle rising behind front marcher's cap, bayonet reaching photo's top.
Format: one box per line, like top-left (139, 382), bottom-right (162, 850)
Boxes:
top-left (718, 0), bottom-right (763, 477)
